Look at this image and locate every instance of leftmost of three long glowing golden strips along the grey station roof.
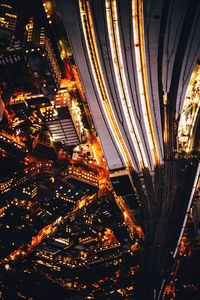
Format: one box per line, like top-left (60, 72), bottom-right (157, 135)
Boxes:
top-left (79, 0), bottom-right (135, 169)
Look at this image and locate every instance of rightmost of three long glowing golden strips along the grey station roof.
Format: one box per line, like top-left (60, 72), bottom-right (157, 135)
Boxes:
top-left (132, 0), bottom-right (161, 165)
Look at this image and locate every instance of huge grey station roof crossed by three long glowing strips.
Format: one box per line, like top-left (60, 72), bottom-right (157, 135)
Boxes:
top-left (55, 1), bottom-right (199, 171)
